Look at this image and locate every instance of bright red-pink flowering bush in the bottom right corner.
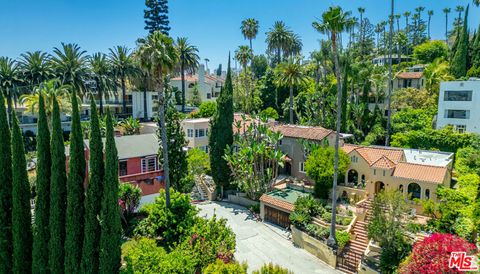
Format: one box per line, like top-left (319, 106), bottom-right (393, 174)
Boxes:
top-left (399, 233), bottom-right (478, 273)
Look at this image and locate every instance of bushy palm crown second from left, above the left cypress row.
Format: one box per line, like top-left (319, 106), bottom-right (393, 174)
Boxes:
top-left (19, 51), bottom-right (53, 90)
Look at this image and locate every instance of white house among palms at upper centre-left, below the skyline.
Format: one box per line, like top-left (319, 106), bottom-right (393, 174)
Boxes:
top-left (170, 65), bottom-right (225, 102)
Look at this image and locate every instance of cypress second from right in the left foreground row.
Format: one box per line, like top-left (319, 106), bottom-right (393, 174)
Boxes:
top-left (81, 96), bottom-right (105, 273)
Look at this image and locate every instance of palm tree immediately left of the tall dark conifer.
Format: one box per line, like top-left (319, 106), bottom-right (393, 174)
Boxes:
top-left (109, 46), bottom-right (138, 114)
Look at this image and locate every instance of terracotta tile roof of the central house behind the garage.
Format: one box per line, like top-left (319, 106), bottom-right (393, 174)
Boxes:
top-left (272, 124), bottom-right (335, 141)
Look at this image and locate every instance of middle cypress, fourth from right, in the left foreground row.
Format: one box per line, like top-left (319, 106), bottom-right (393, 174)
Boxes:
top-left (48, 99), bottom-right (67, 274)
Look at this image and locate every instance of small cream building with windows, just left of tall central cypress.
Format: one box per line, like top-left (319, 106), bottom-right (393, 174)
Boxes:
top-left (182, 118), bottom-right (210, 153)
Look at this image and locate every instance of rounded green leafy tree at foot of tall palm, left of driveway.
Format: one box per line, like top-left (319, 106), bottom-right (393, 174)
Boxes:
top-left (135, 189), bottom-right (197, 248)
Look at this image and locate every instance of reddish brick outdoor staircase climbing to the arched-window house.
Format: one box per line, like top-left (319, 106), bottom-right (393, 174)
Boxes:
top-left (337, 200), bottom-right (372, 274)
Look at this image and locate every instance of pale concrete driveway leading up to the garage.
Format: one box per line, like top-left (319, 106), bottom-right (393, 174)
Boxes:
top-left (197, 202), bottom-right (341, 274)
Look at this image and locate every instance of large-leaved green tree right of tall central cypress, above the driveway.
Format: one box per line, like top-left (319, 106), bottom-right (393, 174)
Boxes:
top-left (224, 114), bottom-right (284, 200)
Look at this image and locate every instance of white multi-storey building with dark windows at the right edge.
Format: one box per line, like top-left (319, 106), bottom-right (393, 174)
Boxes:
top-left (437, 78), bottom-right (480, 134)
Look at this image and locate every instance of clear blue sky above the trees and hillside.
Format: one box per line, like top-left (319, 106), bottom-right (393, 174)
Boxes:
top-left (0, 0), bottom-right (480, 69)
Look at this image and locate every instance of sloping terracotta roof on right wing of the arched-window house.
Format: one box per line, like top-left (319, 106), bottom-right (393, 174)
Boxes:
top-left (393, 162), bottom-right (448, 184)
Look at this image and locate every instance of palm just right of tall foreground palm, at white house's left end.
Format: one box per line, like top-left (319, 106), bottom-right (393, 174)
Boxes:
top-left (175, 37), bottom-right (200, 112)
